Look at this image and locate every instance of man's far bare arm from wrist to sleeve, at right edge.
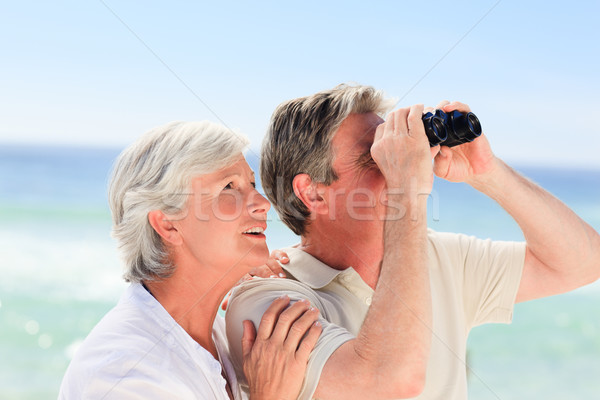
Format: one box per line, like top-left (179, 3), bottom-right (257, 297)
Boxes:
top-left (468, 159), bottom-right (600, 301)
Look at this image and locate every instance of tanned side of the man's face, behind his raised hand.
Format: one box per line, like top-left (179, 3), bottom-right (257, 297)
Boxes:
top-left (324, 113), bottom-right (386, 243)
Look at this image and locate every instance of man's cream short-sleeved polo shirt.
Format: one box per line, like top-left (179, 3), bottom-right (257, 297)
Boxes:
top-left (225, 230), bottom-right (525, 400)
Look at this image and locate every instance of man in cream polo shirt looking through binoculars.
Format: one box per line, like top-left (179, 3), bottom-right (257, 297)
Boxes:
top-left (226, 85), bottom-right (600, 400)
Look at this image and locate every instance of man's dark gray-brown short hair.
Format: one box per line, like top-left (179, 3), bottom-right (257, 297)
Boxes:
top-left (260, 84), bottom-right (393, 235)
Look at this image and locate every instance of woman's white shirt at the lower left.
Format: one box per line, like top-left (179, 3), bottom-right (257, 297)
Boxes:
top-left (58, 283), bottom-right (242, 400)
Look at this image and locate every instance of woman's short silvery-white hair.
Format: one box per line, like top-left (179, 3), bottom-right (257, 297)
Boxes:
top-left (108, 121), bottom-right (248, 282)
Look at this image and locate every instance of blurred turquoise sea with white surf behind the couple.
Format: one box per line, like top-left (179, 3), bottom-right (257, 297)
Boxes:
top-left (0, 145), bottom-right (600, 400)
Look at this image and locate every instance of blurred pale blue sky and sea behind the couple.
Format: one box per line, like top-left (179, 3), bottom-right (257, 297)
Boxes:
top-left (0, 0), bottom-right (600, 400)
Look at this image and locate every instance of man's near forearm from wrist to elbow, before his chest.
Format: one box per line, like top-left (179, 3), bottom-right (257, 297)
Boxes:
top-left (356, 196), bottom-right (432, 394)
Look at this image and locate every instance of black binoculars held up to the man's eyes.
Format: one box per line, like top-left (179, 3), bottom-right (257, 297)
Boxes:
top-left (422, 110), bottom-right (481, 147)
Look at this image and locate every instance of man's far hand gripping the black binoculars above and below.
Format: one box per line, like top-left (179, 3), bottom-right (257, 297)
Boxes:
top-left (433, 101), bottom-right (498, 183)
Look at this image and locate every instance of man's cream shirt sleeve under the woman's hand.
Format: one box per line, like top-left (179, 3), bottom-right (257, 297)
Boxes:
top-left (225, 278), bottom-right (355, 399)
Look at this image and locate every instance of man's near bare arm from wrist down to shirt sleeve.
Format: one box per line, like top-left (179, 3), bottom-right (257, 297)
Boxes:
top-left (315, 196), bottom-right (432, 399)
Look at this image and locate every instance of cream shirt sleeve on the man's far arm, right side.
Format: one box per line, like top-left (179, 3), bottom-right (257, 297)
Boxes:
top-left (437, 233), bottom-right (526, 328)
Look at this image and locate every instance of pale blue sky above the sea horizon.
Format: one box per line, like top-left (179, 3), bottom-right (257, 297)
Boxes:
top-left (0, 0), bottom-right (600, 168)
